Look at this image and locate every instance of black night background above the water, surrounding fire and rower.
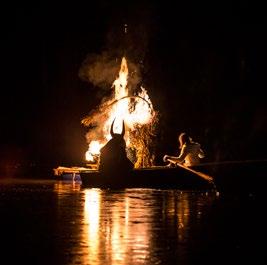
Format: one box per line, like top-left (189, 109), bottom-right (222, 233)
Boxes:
top-left (0, 0), bottom-right (267, 171)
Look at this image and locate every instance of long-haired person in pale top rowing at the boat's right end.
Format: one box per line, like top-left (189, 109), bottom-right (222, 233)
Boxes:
top-left (163, 133), bottom-right (205, 167)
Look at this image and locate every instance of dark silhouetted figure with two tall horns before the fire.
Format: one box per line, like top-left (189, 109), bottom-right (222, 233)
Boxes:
top-left (99, 119), bottom-right (134, 175)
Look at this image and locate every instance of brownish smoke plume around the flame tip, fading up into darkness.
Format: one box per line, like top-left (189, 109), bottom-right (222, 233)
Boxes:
top-left (79, 2), bottom-right (155, 92)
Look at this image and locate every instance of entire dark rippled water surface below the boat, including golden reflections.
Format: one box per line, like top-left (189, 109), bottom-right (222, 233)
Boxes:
top-left (0, 179), bottom-right (267, 265)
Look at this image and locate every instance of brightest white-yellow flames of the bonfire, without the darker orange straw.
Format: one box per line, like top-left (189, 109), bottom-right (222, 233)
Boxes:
top-left (85, 57), bottom-right (155, 161)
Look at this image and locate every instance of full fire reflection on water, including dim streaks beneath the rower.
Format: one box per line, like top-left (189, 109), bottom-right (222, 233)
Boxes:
top-left (76, 189), bottom-right (217, 265)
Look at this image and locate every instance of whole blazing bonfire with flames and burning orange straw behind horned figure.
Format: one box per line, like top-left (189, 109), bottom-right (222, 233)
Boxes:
top-left (82, 57), bottom-right (158, 168)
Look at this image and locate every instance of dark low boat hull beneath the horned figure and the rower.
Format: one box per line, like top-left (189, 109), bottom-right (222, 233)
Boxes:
top-left (80, 166), bottom-right (215, 190)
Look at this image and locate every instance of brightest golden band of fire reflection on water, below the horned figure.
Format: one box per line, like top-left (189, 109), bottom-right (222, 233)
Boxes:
top-left (82, 189), bottom-right (151, 264)
